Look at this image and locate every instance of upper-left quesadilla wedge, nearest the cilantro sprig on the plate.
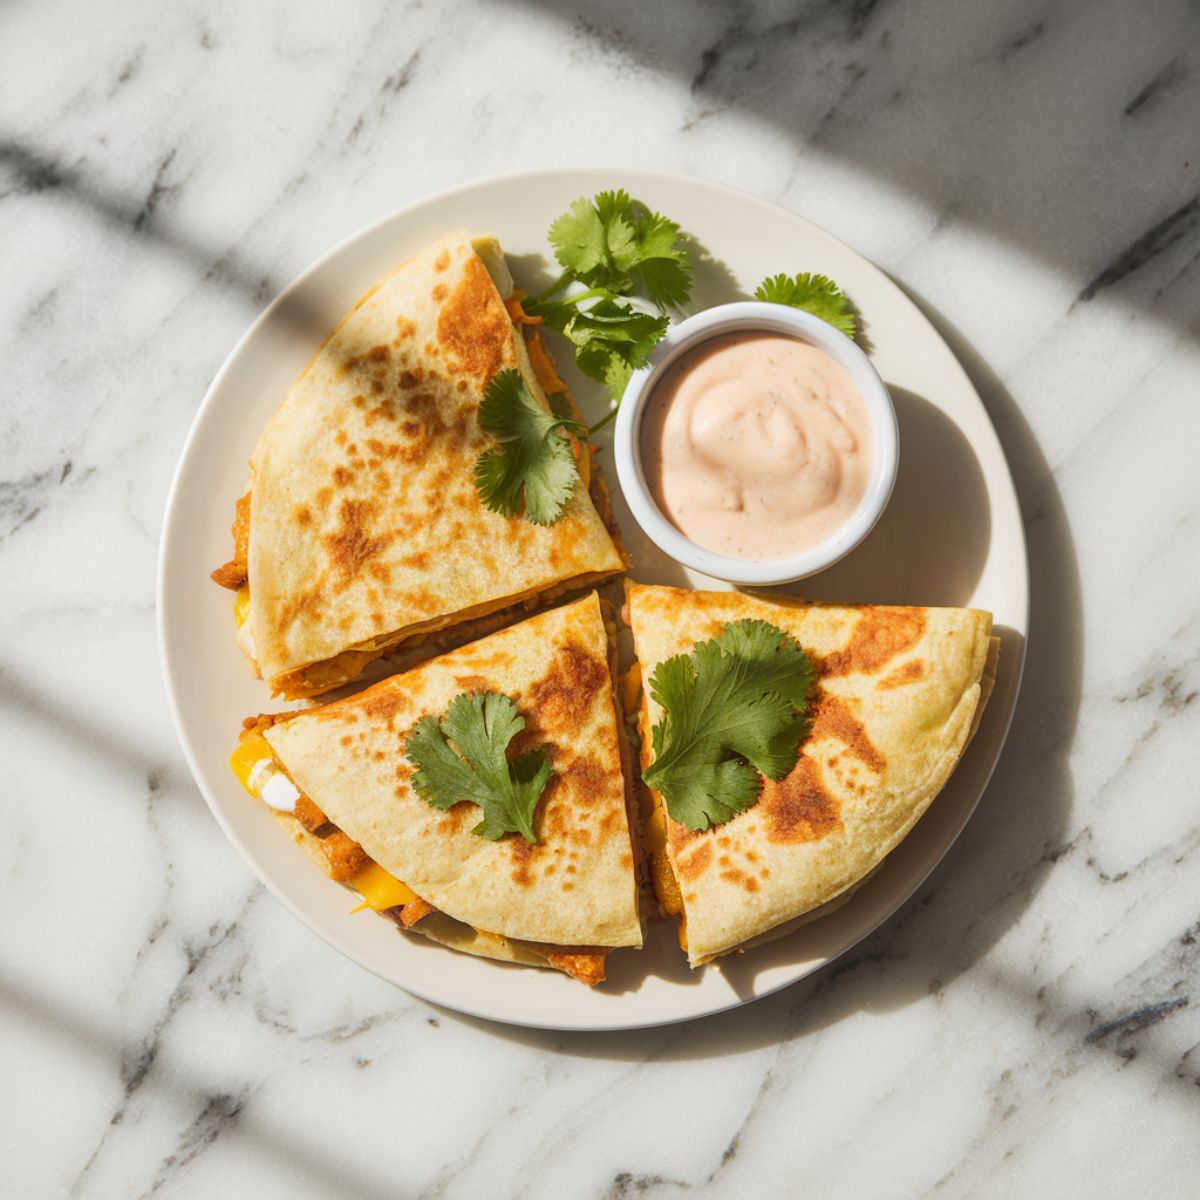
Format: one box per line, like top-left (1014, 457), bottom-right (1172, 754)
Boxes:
top-left (212, 234), bottom-right (625, 698)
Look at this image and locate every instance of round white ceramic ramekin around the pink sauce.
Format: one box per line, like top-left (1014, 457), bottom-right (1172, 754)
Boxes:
top-left (613, 300), bottom-right (900, 587)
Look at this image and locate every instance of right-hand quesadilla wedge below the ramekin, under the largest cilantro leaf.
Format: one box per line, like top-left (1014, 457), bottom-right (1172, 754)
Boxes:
top-left (623, 581), bottom-right (1000, 966)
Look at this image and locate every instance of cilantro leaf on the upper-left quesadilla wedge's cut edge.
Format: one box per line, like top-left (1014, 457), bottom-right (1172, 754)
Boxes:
top-left (475, 367), bottom-right (580, 524)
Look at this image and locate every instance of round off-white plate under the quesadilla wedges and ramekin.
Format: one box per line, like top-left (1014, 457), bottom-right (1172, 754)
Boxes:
top-left (158, 169), bottom-right (1028, 1030)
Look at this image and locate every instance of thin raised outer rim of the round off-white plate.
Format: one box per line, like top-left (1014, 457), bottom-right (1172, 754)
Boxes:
top-left (155, 164), bottom-right (1031, 1033)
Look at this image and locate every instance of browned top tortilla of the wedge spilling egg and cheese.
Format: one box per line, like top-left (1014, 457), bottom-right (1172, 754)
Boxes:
top-left (264, 593), bottom-right (642, 961)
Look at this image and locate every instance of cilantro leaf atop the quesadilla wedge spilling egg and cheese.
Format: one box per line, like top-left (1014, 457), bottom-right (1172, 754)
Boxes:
top-left (404, 691), bottom-right (554, 842)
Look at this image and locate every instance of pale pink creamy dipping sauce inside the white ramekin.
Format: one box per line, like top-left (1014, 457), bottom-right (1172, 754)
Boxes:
top-left (641, 332), bottom-right (871, 560)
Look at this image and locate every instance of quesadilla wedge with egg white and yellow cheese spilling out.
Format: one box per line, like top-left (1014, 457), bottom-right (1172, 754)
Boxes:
top-left (230, 593), bottom-right (642, 984)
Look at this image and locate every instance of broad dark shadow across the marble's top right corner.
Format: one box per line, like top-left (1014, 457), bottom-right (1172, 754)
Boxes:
top-left (510, 0), bottom-right (1200, 336)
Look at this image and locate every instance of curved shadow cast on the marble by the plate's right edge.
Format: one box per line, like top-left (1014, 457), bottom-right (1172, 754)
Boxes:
top-left (456, 307), bottom-right (1082, 1061)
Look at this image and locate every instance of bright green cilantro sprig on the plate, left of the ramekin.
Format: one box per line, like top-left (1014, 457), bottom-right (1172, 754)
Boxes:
top-left (524, 188), bottom-right (691, 428)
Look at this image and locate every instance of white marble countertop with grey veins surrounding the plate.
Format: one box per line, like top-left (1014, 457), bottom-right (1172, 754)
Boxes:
top-left (0, 0), bottom-right (1200, 1198)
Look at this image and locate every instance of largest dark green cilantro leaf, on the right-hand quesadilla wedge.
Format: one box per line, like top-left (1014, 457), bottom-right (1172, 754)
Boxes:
top-left (642, 620), bottom-right (816, 830)
